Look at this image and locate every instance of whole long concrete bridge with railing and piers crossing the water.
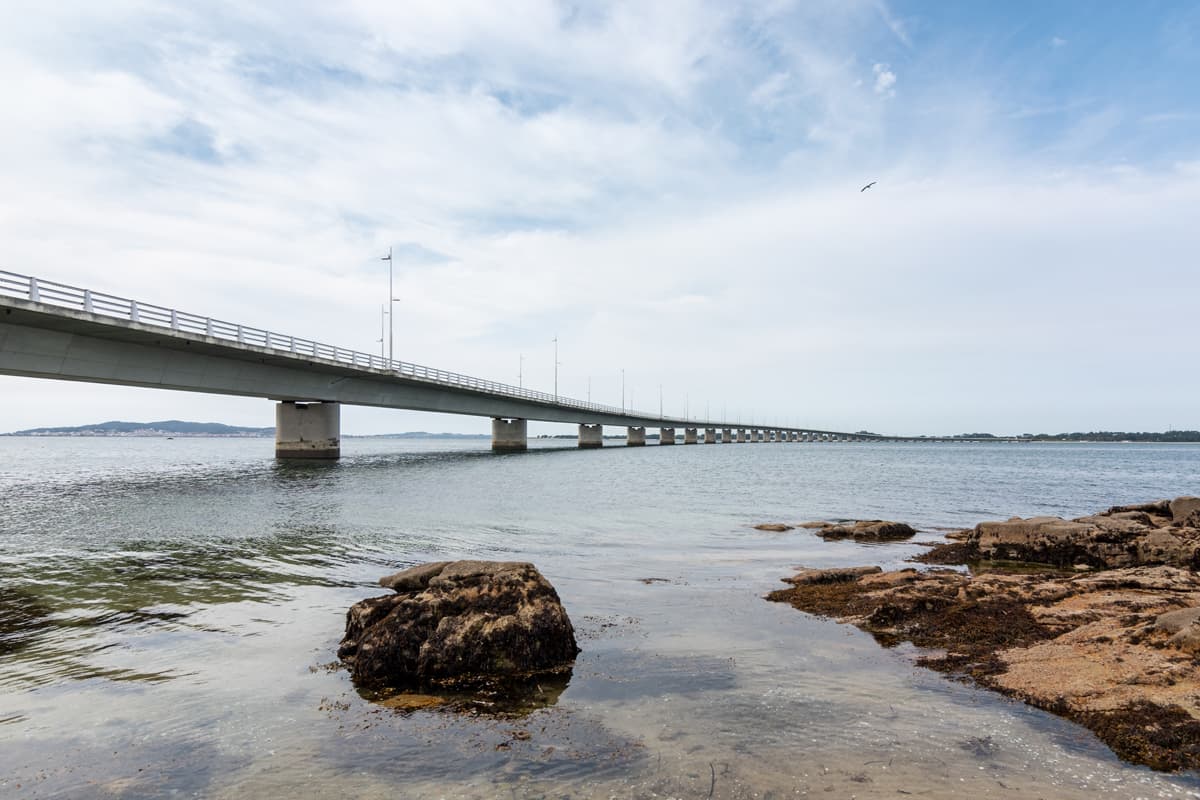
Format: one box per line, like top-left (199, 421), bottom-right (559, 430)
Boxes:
top-left (0, 271), bottom-right (1012, 458)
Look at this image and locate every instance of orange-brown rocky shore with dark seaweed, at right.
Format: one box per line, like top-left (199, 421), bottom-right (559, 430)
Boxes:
top-left (768, 498), bottom-right (1200, 770)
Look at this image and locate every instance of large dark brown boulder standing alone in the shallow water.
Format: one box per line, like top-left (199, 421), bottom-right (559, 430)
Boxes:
top-left (337, 561), bottom-right (580, 688)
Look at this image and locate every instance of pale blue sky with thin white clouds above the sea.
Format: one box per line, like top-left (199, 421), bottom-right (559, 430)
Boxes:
top-left (0, 0), bottom-right (1200, 434)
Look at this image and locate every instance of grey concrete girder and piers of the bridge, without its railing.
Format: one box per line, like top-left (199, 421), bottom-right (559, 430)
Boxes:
top-left (0, 297), bottom-right (916, 458)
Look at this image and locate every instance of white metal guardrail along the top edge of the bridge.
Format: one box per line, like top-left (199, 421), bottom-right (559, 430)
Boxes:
top-left (0, 270), bottom-right (656, 419)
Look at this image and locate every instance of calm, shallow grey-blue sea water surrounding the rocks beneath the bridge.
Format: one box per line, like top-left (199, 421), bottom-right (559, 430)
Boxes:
top-left (0, 438), bottom-right (1200, 799)
